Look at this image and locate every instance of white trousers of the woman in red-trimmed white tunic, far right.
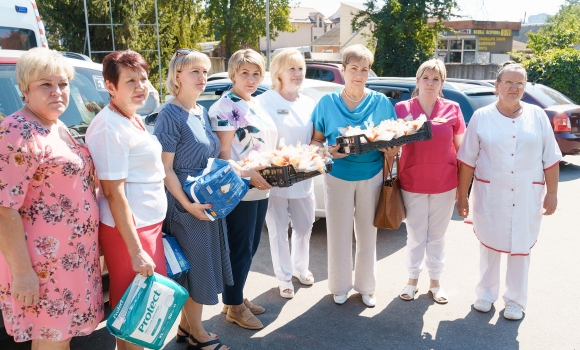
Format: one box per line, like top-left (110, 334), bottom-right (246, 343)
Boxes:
top-left (475, 244), bottom-right (530, 310)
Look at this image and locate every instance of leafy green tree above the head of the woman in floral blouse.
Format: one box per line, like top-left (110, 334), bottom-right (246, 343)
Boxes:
top-left (206, 0), bottom-right (294, 62)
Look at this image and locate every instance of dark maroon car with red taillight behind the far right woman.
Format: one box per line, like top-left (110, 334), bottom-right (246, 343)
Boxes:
top-left (447, 79), bottom-right (580, 155)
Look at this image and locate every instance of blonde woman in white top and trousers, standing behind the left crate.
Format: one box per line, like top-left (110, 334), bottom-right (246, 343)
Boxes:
top-left (257, 49), bottom-right (315, 299)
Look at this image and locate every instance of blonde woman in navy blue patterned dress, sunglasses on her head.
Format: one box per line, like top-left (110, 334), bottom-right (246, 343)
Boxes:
top-left (153, 49), bottom-right (245, 349)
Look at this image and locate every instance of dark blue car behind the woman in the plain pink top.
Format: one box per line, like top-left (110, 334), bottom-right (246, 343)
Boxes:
top-left (366, 78), bottom-right (497, 124)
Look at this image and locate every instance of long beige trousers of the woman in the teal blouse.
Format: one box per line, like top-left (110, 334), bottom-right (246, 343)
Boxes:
top-left (324, 171), bottom-right (383, 294)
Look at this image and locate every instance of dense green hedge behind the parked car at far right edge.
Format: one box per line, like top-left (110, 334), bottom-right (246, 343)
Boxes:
top-left (511, 48), bottom-right (580, 103)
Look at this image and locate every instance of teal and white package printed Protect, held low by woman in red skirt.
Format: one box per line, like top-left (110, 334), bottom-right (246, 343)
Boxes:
top-left (107, 273), bottom-right (188, 349)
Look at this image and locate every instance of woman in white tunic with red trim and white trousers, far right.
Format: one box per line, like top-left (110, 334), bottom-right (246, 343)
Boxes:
top-left (457, 62), bottom-right (562, 320)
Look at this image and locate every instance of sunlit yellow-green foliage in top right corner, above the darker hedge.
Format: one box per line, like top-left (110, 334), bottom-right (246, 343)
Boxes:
top-left (527, 0), bottom-right (580, 53)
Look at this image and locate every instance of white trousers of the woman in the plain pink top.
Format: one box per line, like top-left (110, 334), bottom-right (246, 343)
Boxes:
top-left (401, 189), bottom-right (456, 280)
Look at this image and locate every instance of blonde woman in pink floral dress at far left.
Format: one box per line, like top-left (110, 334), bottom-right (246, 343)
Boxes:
top-left (0, 48), bottom-right (103, 350)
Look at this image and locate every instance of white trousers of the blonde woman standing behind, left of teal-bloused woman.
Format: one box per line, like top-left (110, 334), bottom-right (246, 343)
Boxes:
top-left (266, 194), bottom-right (314, 281)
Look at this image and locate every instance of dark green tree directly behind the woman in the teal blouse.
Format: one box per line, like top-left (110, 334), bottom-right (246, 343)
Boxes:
top-left (352, 0), bottom-right (458, 76)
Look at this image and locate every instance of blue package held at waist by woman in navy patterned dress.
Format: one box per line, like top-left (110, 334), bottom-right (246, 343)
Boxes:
top-left (183, 158), bottom-right (250, 221)
